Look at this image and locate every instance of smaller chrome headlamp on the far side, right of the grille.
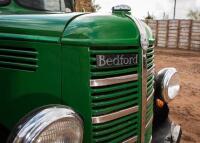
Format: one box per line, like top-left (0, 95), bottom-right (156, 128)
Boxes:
top-left (157, 68), bottom-right (180, 103)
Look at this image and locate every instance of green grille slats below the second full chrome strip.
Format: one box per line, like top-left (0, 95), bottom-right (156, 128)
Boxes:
top-left (93, 114), bottom-right (138, 143)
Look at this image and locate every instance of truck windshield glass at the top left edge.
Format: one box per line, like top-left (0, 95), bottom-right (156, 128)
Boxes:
top-left (16, 0), bottom-right (73, 12)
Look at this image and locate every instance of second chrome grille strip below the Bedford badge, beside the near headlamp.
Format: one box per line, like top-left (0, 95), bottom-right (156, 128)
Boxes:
top-left (92, 106), bottom-right (139, 124)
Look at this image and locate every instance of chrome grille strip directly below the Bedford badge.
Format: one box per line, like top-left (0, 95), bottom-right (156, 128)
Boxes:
top-left (90, 74), bottom-right (138, 87)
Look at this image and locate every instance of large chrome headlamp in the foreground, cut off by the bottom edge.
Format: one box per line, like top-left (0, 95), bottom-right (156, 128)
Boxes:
top-left (10, 106), bottom-right (83, 143)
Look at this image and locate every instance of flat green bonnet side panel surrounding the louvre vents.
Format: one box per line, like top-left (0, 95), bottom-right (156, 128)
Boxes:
top-left (0, 39), bottom-right (61, 129)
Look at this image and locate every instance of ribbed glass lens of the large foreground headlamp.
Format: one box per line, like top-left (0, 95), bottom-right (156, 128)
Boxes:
top-left (35, 118), bottom-right (83, 143)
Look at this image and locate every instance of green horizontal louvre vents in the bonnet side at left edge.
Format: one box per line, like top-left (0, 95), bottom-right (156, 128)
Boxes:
top-left (0, 47), bottom-right (38, 72)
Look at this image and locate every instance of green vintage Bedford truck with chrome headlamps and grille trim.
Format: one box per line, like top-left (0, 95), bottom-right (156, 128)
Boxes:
top-left (0, 0), bottom-right (181, 143)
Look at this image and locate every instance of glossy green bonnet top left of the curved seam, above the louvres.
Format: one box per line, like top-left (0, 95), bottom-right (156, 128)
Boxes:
top-left (0, 13), bottom-right (83, 43)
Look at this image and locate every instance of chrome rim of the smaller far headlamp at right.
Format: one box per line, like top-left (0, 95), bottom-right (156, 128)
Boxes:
top-left (158, 68), bottom-right (180, 103)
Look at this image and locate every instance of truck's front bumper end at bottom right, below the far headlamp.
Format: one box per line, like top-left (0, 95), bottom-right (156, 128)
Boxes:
top-left (152, 120), bottom-right (182, 143)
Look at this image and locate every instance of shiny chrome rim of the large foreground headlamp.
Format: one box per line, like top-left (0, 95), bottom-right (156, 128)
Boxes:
top-left (8, 105), bottom-right (83, 143)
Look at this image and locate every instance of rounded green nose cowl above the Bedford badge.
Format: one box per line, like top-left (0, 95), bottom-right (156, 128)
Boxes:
top-left (62, 13), bottom-right (139, 46)
